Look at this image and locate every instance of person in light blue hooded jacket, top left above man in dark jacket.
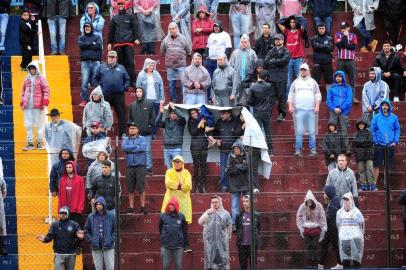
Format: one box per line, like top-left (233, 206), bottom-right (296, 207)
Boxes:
top-left (80, 2), bottom-right (104, 39)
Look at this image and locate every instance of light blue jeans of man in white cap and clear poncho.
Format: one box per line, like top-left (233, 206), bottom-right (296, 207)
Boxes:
top-left (294, 109), bottom-right (316, 151)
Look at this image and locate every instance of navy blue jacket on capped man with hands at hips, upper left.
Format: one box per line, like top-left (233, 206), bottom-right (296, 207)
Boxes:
top-left (92, 63), bottom-right (131, 97)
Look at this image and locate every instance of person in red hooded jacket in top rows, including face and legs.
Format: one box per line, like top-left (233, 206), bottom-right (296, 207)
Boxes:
top-left (192, 6), bottom-right (214, 55)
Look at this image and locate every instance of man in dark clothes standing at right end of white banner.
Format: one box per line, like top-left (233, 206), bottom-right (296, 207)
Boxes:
top-left (248, 70), bottom-right (275, 155)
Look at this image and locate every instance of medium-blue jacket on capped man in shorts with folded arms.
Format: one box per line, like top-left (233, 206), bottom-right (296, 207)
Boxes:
top-left (121, 135), bottom-right (147, 167)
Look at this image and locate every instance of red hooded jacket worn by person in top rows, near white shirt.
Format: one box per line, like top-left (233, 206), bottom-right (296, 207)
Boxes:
top-left (192, 6), bottom-right (214, 51)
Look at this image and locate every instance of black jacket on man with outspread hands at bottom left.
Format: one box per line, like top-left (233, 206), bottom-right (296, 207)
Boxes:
top-left (44, 208), bottom-right (81, 255)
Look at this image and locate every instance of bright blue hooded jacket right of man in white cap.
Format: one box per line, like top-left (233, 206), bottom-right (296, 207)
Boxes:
top-left (327, 70), bottom-right (352, 115)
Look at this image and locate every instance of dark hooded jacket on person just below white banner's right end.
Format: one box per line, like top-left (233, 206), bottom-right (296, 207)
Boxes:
top-left (225, 141), bottom-right (249, 193)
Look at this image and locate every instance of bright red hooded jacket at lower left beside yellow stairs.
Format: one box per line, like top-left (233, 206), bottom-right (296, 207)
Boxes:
top-left (58, 161), bottom-right (85, 214)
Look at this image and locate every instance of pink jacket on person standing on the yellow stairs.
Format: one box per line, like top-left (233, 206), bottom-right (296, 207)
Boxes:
top-left (20, 75), bottom-right (49, 110)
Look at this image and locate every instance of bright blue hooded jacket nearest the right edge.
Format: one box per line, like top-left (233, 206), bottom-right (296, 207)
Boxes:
top-left (371, 99), bottom-right (400, 145)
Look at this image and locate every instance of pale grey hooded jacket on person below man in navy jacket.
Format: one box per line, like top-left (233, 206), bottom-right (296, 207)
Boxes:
top-left (82, 86), bottom-right (113, 129)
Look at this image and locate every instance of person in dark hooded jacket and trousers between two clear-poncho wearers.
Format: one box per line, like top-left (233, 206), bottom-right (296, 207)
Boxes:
top-left (318, 185), bottom-right (343, 269)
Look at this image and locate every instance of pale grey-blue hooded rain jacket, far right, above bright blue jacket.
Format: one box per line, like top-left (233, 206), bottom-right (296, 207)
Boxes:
top-left (362, 67), bottom-right (390, 113)
